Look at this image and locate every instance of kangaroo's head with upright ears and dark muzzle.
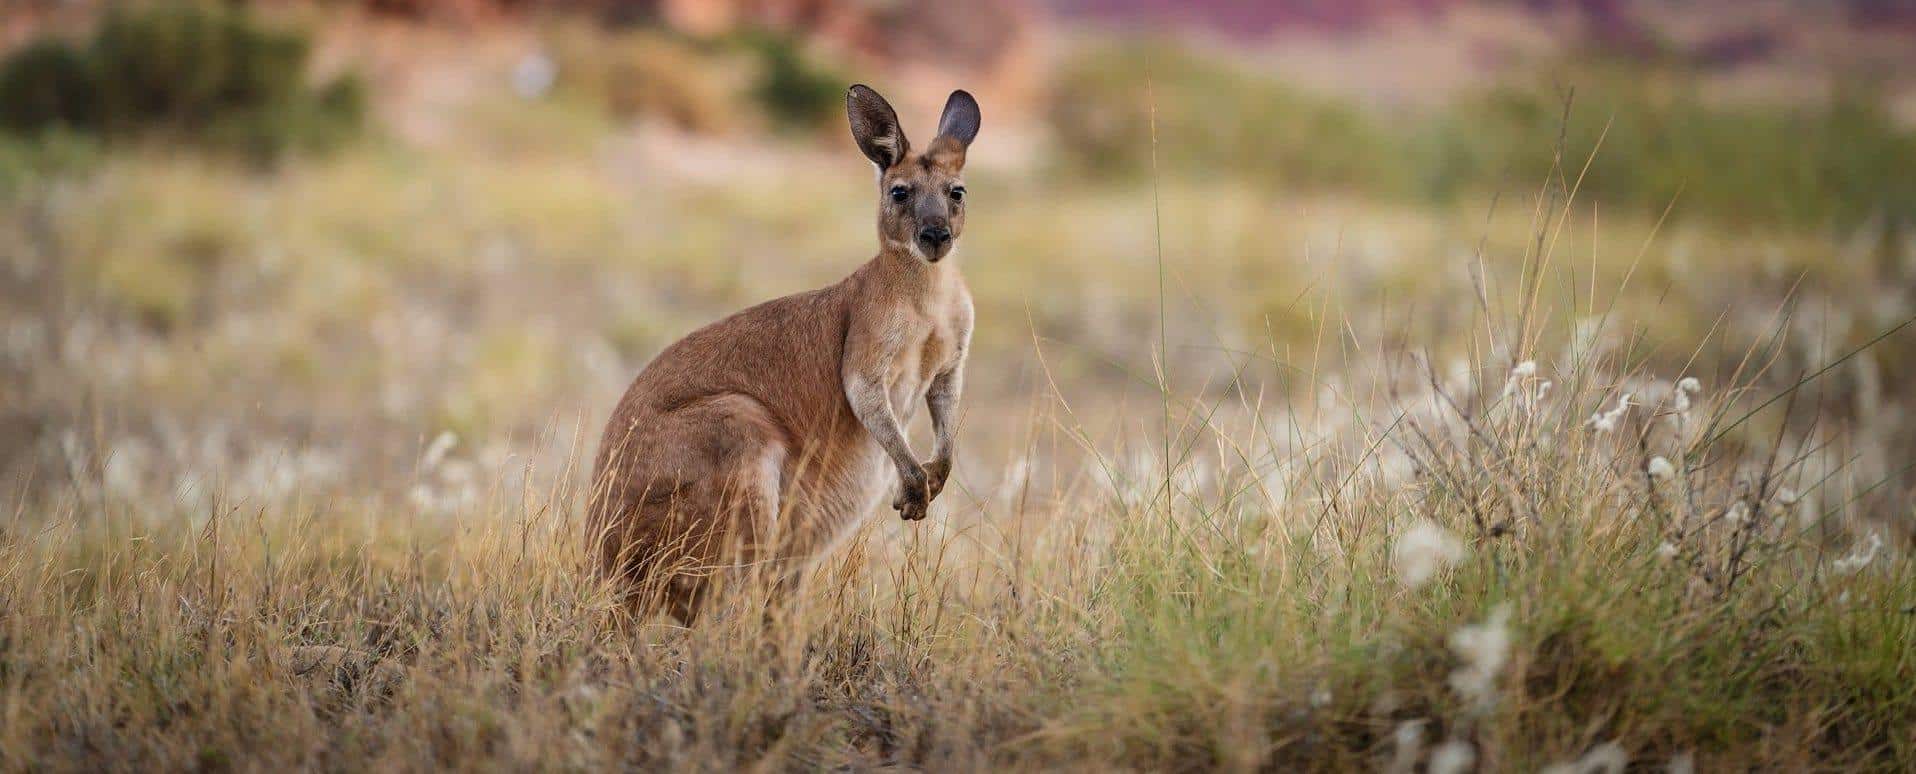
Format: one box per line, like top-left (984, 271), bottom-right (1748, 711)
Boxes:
top-left (845, 84), bottom-right (979, 262)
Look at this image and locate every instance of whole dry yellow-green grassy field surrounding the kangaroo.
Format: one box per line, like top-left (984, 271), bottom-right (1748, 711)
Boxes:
top-left (0, 13), bottom-right (1916, 772)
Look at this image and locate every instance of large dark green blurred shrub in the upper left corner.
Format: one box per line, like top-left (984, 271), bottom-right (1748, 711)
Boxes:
top-left (0, 2), bottom-right (364, 157)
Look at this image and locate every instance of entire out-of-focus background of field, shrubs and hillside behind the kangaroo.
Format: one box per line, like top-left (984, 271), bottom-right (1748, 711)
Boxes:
top-left (0, 0), bottom-right (1916, 519)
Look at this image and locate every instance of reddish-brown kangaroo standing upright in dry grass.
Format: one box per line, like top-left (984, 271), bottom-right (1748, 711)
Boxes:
top-left (586, 84), bottom-right (979, 625)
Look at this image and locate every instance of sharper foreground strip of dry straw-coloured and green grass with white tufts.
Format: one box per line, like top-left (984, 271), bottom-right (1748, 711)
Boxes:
top-left (0, 318), bottom-right (1916, 768)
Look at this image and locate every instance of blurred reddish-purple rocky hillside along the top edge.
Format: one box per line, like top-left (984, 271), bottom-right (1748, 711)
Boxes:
top-left (11, 0), bottom-right (1916, 112)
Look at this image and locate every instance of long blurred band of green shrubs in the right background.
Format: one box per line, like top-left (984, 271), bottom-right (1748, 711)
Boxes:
top-left (1050, 42), bottom-right (1916, 230)
